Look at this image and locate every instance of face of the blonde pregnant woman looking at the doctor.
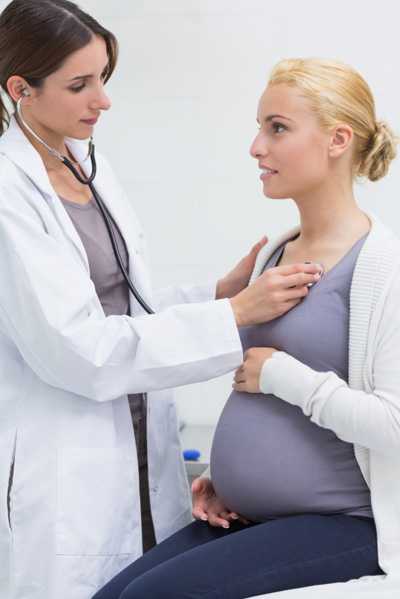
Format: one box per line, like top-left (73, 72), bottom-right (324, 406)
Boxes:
top-left (250, 84), bottom-right (330, 199)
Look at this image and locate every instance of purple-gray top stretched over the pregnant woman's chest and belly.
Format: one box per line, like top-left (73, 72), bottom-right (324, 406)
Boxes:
top-left (211, 235), bottom-right (372, 521)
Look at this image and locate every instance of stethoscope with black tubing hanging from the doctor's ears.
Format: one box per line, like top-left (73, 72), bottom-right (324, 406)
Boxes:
top-left (17, 90), bottom-right (154, 314)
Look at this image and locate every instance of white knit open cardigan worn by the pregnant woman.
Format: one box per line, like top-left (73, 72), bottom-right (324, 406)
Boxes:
top-left (245, 213), bottom-right (400, 599)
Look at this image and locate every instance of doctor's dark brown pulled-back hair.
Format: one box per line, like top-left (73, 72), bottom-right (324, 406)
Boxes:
top-left (0, 0), bottom-right (118, 135)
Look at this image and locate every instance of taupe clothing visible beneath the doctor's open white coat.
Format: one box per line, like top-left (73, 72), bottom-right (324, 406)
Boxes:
top-left (60, 198), bottom-right (155, 550)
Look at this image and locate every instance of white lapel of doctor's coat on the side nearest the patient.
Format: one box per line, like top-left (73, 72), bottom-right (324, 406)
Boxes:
top-left (67, 140), bottom-right (152, 315)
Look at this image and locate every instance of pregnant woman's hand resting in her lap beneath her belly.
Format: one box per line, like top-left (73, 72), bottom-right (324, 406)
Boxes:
top-left (192, 477), bottom-right (249, 528)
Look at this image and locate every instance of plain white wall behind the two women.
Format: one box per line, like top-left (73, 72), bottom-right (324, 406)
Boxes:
top-left (3, 0), bottom-right (400, 423)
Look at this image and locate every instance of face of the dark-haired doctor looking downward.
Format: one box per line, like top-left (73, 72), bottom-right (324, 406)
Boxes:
top-left (22, 36), bottom-right (111, 139)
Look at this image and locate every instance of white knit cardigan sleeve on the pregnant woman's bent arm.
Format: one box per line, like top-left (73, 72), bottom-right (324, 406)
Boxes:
top-left (260, 277), bottom-right (400, 453)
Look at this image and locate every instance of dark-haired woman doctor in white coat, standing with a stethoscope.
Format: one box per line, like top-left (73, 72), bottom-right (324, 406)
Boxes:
top-left (0, 0), bottom-right (318, 599)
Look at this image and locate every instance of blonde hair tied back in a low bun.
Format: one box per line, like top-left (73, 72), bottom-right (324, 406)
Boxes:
top-left (268, 58), bottom-right (399, 181)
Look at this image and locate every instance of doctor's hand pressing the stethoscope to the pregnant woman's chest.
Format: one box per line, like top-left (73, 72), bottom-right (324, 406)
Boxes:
top-left (230, 262), bottom-right (322, 327)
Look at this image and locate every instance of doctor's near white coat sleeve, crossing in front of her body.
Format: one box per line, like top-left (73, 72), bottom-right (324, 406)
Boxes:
top-left (0, 195), bottom-right (242, 401)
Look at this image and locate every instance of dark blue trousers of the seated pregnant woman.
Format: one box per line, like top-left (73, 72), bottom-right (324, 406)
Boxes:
top-left (94, 515), bottom-right (382, 599)
